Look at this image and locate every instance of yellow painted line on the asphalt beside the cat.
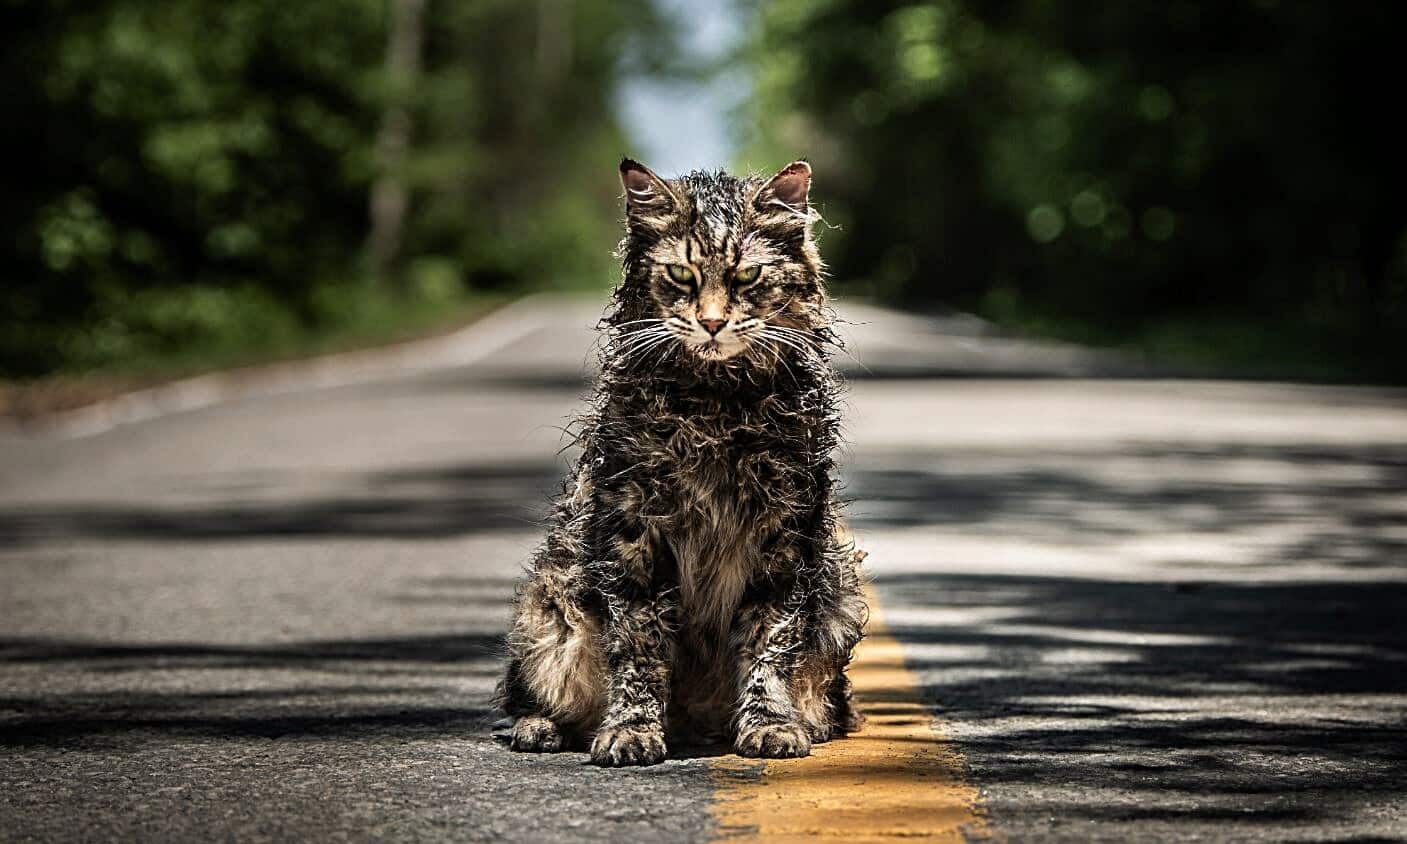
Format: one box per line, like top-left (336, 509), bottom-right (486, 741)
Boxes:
top-left (711, 592), bottom-right (991, 841)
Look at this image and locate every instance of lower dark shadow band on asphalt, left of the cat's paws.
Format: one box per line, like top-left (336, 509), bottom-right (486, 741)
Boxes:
top-left (0, 634), bottom-right (502, 750)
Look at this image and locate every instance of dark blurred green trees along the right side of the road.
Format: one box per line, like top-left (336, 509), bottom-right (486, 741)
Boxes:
top-left (744, 0), bottom-right (1407, 376)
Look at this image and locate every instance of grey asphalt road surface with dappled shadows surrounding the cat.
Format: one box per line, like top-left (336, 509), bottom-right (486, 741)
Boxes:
top-left (0, 300), bottom-right (1407, 841)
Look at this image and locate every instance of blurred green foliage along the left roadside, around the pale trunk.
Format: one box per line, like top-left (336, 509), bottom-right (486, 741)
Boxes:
top-left (0, 0), bottom-right (658, 376)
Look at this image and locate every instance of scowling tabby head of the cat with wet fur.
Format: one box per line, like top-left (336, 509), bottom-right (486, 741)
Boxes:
top-left (612, 159), bottom-right (826, 364)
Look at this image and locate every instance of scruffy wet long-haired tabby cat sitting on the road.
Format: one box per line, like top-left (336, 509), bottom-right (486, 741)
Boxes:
top-left (498, 159), bottom-right (868, 767)
